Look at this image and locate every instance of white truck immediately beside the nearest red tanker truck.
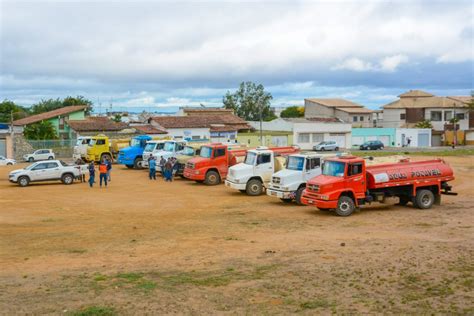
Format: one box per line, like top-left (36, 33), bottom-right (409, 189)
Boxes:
top-left (267, 152), bottom-right (341, 205)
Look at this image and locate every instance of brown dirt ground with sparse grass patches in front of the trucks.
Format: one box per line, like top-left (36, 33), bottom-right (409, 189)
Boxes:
top-left (0, 156), bottom-right (474, 315)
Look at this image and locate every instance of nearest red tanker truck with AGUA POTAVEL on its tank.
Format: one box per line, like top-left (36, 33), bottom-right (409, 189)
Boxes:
top-left (301, 156), bottom-right (457, 216)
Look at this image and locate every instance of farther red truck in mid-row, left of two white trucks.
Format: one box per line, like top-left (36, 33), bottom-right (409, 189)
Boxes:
top-left (183, 143), bottom-right (299, 185)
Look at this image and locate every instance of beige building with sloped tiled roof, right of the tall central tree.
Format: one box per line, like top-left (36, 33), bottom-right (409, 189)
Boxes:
top-left (304, 98), bottom-right (373, 127)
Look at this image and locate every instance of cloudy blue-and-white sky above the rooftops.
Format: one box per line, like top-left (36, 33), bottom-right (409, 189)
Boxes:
top-left (0, 0), bottom-right (474, 109)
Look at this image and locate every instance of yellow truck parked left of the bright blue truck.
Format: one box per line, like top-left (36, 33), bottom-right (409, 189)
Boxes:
top-left (87, 134), bottom-right (130, 162)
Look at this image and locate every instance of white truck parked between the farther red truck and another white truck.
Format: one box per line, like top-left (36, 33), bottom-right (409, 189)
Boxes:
top-left (225, 147), bottom-right (294, 196)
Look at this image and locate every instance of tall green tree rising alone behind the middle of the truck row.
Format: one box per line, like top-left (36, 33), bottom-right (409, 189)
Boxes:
top-left (222, 81), bottom-right (276, 121)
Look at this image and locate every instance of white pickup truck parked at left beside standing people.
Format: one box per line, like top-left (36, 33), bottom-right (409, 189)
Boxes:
top-left (8, 160), bottom-right (81, 187)
